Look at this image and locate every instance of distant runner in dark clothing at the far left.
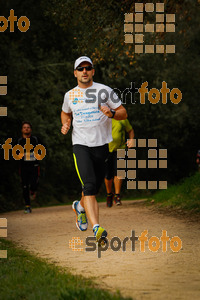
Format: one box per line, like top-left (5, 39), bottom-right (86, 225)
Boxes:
top-left (18, 121), bottom-right (40, 213)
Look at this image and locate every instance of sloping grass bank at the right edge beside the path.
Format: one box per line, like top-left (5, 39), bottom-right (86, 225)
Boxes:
top-left (149, 172), bottom-right (200, 213)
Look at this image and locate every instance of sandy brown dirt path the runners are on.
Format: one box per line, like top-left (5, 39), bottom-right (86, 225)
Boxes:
top-left (0, 201), bottom-right (200, 300)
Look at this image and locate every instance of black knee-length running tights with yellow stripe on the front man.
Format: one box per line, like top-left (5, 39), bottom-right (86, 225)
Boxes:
top-left (73, 144), bottom-right (109, 196)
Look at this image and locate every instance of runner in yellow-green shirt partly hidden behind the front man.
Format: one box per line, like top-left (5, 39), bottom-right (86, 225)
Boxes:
top-left (105, 119), bottom-right (134, 207)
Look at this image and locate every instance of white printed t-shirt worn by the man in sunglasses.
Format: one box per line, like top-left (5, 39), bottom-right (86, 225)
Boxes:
top-left (62, 82), bottom-right (121, 147)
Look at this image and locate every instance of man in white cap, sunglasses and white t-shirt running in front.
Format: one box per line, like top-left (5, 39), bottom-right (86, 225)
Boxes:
top-left (61, 56), bottom-right (127, 244)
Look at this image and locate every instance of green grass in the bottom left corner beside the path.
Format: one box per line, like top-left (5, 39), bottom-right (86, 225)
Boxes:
top-left (0, 239), bottom-right (131, 300)
